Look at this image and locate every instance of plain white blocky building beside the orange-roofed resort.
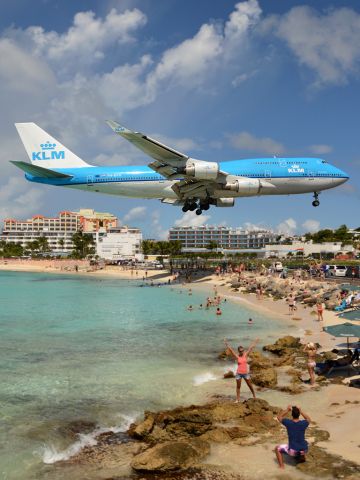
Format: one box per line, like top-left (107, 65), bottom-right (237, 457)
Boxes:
top-left (96, 226), bottom-right (143, 261)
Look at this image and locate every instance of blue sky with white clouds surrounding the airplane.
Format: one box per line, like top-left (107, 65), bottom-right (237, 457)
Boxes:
top-left (0, 0), bottom-right (360, 238)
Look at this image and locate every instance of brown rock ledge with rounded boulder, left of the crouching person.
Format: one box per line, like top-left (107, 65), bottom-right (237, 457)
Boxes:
top-left (128, 399), bottom-right (280, 472)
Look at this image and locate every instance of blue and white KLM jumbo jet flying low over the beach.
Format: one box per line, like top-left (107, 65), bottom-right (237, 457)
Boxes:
top-left (12, 120), bottom-right (349, 215)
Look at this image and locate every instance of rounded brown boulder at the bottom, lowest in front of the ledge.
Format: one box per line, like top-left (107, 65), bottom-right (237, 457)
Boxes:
top-left (131, 439), bottom-right (210, 472)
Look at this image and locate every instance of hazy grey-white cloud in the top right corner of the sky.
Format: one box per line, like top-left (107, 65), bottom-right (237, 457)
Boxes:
top-left (263, 6), bottom-right (360, 86)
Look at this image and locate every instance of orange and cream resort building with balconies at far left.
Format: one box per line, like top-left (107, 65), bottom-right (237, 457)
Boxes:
top-left (0, 209), bottom-right (117, 254)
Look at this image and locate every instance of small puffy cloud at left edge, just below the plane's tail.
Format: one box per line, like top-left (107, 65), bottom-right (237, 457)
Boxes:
top-left (0, 177), bottom-right (43, 219)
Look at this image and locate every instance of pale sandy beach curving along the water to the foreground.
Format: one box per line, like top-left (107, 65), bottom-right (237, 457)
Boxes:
top-left (0, 261), bottom-right (360, 480)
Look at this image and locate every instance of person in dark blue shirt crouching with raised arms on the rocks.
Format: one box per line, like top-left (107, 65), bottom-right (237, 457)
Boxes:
top-left (275, 405), bottom-right (311, 468)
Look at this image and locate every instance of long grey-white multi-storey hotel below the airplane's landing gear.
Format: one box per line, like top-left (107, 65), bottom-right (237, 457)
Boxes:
top-left (169, 225), bottom-right (279, 252)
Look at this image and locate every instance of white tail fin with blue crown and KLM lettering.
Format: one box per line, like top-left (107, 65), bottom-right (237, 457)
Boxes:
top-left (15, 122), bottom-right (92, 169)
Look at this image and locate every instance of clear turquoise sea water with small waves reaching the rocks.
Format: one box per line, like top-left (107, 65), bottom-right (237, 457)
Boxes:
top-left (0, 272), bottom-right (282, 480)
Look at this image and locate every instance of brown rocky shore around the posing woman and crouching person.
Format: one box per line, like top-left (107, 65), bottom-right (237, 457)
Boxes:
top-left (52, 336), bottom-right (360, 480)
